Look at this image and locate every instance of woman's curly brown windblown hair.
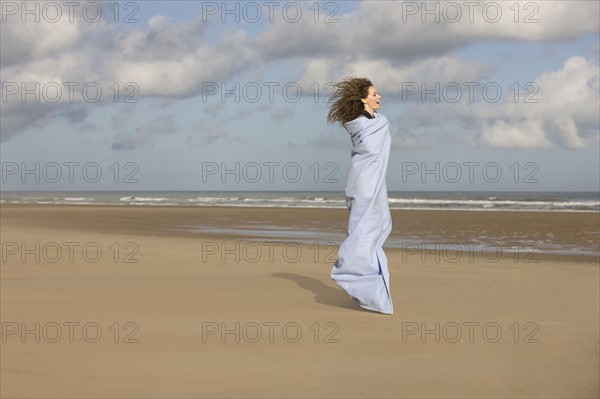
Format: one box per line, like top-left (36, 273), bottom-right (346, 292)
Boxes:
top-left (327, 77), bottom-right (373, 125)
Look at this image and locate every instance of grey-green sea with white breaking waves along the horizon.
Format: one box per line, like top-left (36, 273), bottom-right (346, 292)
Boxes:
top-left (0, 191), bottom-right (600, 212)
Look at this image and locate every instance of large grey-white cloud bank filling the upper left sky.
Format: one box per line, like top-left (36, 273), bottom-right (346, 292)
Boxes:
top-left (0, 2), bottom-right (250, 139)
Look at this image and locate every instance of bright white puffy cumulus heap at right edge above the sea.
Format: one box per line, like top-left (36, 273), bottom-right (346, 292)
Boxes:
top-left (474, 56), bottom-right (600, 149)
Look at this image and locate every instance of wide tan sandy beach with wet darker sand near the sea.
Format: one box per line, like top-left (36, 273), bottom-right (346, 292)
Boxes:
top-left (0, 204), bottom-right (600, 398)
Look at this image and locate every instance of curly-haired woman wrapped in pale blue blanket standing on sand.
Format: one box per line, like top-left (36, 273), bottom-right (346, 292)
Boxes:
top-left (327, 78), bottom-right (393, 314)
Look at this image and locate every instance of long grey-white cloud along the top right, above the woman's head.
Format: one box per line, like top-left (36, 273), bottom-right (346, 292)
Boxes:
top-left (250, 1), bottom-right (600, 62)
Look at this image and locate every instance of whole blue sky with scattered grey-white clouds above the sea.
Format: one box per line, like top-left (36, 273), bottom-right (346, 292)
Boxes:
top-left (0, 0), bottom-right (600, 191)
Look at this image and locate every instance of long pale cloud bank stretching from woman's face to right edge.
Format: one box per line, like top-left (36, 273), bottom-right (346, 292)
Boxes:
top-left (382, 56), bottom-right (600, 150)
